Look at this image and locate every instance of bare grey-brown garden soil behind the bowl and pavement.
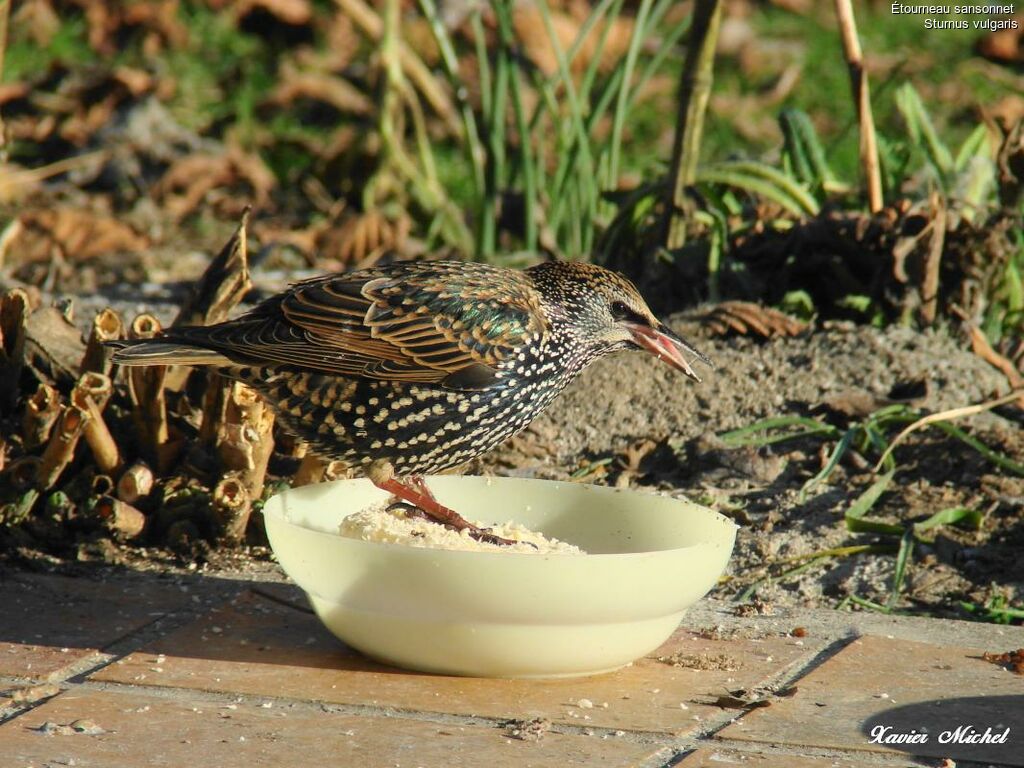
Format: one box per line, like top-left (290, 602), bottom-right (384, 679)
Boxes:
top-left (2, 259), bottom-right (1024, 616)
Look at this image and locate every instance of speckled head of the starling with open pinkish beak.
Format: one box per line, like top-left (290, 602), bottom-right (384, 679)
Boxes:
top-left (528, 261), bottom-right (714, 381)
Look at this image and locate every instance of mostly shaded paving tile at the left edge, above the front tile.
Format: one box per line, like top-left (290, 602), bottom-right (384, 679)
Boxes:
top-left (0, 573), bottom-right (188, 680)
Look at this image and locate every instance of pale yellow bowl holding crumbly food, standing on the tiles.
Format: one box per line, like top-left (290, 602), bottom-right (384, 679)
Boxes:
top-left (263, 475), bottom-right (736, 677)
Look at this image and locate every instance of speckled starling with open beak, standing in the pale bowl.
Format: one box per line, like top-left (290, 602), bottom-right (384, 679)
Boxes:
top-left (108, 261), bottom-right (711, 541)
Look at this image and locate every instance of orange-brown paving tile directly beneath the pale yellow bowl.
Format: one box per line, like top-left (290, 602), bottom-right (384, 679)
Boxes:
top-left (92, 594), bottom-right (815, 735)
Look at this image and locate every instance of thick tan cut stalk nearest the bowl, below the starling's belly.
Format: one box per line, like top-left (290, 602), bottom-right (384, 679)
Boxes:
top-left (217, 383), bottom-right (273, 499)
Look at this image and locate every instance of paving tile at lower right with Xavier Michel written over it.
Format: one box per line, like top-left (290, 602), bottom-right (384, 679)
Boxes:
top-left (718, 636), bottom-right (1024, 766)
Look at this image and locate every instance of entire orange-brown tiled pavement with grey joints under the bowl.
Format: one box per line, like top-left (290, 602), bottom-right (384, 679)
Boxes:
top-left (0, 570), bottom-right (1024, 768)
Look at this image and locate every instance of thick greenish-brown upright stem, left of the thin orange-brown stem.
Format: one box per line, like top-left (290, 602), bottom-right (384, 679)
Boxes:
top-left (663, 0), bottom-right (722, 251)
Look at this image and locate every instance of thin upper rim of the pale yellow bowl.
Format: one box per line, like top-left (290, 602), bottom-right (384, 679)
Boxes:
top-left (262, 475), bottom-right (739, 562)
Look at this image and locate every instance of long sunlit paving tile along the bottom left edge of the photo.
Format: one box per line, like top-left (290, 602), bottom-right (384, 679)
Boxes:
top-left (0, 688), bottom-right (657, 768)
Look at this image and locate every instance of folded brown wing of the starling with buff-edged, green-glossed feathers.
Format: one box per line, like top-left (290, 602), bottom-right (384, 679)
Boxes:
top-left (189, 262), bottom-right (546, 388)
